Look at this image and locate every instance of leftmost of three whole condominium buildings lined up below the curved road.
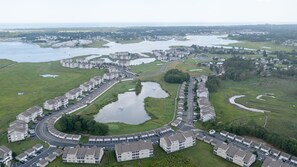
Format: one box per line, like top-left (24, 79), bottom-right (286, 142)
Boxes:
top-left (62, 146), bottom-right (104, 164)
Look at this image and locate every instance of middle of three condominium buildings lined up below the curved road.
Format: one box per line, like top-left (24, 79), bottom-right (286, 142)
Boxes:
top-left (115, 140), bottom-right (154, 162)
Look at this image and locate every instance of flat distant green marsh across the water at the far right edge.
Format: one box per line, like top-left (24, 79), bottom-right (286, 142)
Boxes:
top-left (228, 41), bottom-right (297, 52)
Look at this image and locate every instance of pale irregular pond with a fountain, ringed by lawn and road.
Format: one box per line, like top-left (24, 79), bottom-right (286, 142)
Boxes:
top-left (95, 82), bottom-right (169, 125)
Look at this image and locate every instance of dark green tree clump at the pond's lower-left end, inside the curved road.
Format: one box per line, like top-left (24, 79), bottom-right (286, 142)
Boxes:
top-left (58, 115), bottom-right (109, 136)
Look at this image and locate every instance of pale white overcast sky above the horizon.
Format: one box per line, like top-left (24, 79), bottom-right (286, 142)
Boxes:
top-left (0, 0), bottom-right (297, 23)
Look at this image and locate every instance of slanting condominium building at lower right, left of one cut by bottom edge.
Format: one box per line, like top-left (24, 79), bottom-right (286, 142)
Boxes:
top-left (213, 142), bottom-right (256, 167)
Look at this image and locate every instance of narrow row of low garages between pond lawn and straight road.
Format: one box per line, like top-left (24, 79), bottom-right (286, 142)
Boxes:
top-left (171, 82), bottom-right (186, 127)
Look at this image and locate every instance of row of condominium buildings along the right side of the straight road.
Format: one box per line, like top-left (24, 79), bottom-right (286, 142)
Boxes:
top-left (196, 75), bottom-right (216, 122)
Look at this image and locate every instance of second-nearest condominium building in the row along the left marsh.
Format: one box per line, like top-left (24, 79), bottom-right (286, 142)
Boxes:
top-left (16, 106), bottom-right (43, 123)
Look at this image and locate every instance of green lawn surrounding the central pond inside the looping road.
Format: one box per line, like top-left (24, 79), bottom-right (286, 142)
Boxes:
top-left (76, 75), bottom-right (179, 135)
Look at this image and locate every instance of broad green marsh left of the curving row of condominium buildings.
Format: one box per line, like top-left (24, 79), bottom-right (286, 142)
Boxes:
top-left (0, 60), bottom-right (103, 147)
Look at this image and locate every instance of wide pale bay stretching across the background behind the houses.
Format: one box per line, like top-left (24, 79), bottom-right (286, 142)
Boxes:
top-left (0, 36), bottom-right (237, 64)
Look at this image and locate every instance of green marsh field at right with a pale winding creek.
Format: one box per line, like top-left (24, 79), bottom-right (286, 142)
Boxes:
top-left (210, 78), bottom-right (297, 138)
